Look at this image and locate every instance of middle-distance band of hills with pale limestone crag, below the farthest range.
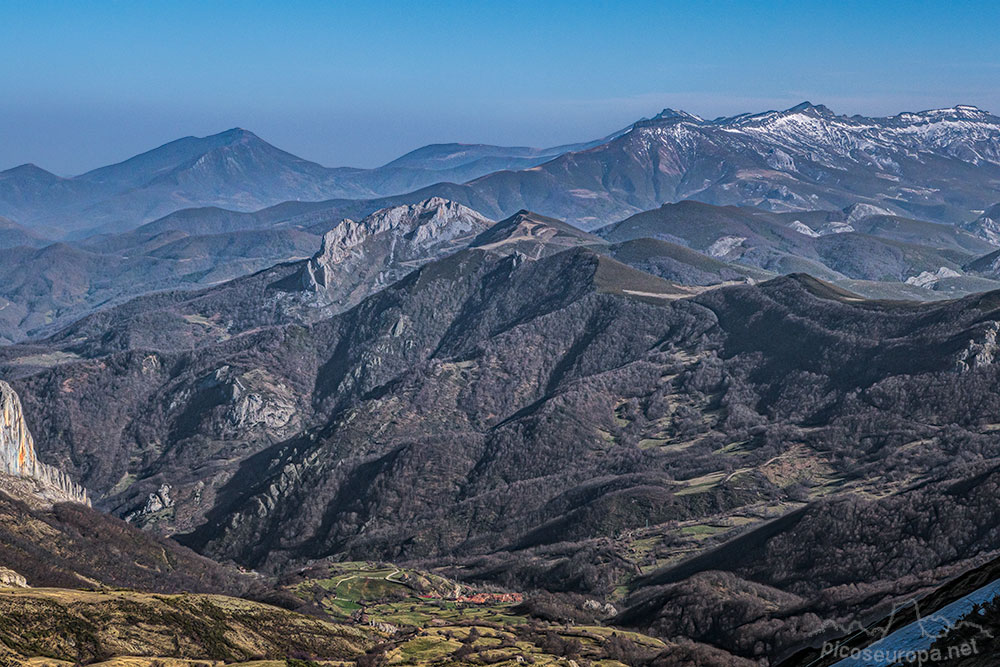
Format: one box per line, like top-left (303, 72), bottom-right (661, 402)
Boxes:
top-left (0, 196), bottom-right (1000, 342)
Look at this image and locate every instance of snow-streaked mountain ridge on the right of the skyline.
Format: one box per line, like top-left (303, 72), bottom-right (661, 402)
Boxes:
top-left (402, 103), bottom-right (1000, 231)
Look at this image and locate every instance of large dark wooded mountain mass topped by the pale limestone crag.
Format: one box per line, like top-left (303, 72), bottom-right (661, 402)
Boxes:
top-left (0, 194), bottom-right (1000, 664)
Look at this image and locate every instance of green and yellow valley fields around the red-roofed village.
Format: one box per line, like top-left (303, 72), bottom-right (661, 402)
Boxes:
top-left (278, 562), bottom-right (667, 665)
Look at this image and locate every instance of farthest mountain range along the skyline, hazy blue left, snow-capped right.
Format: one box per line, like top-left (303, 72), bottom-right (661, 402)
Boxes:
top-left (0, 103), bottom-right (1000, 238)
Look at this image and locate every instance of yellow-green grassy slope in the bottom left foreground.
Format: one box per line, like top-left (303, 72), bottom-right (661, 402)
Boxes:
top-left (0, 589), bottom-right (374, 663)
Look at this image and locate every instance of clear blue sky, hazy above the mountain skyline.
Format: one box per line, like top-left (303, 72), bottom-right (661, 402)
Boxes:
top-left (0, 0), bottom-right (1000, 175)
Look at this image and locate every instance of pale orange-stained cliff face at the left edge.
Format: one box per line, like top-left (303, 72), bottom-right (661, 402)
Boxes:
top-left (0, 380), bottom-right (90, 505)
